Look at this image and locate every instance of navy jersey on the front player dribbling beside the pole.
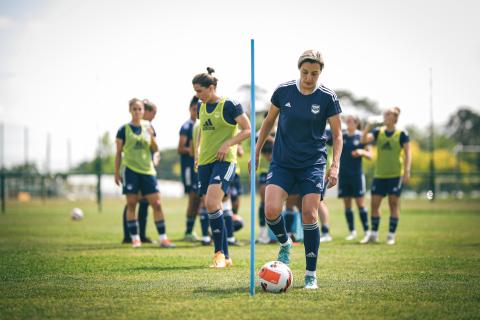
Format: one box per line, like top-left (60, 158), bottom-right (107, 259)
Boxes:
top-left (271, 80), bottom-right (342, 169)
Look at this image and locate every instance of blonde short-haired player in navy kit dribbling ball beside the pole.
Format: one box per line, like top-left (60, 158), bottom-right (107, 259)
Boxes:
top-left (255, 50), bottom-right (342, 289)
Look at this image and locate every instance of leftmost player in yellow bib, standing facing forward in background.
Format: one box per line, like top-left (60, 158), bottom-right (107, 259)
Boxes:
top-left (115, 98), bottom-right (175, 248)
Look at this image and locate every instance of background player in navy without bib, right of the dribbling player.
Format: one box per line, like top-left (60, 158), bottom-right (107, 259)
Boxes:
top-left (332, 115), bottom-right (372, 241)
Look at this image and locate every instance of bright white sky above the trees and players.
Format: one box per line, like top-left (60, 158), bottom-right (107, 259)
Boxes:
top-left (0, 0), bottom-right (480, 170)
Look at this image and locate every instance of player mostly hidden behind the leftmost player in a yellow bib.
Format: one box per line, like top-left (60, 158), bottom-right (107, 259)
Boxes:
top-left (122, 99), bottom-right (160, 243)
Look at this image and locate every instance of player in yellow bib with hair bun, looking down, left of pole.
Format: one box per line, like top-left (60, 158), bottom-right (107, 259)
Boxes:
top-left (192, 68), bottom-right (250, 268)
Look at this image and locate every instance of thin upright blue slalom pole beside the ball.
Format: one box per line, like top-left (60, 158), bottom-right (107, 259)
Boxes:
top-left (250, 39), bottom-right (256, 296)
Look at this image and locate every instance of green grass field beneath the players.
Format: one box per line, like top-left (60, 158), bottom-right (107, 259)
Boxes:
top-left (0, 198), bottom-right (480, 320)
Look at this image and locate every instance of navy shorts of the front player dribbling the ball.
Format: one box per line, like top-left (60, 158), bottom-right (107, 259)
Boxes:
top-left (267, 162), bottom-right (325, 198)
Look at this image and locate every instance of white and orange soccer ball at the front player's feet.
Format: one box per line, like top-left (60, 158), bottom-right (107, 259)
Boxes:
top-left (258, 261), bottom-right (293, 293)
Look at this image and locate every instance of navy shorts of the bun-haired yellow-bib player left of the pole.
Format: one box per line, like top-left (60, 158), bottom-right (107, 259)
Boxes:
top-left (198, 161), bottom-right (236, 196)
